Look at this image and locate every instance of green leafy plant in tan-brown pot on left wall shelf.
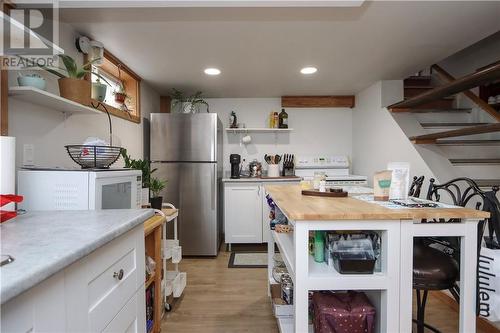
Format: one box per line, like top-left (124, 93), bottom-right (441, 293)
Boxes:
top-left (31, 54), bottom-right (107, 105)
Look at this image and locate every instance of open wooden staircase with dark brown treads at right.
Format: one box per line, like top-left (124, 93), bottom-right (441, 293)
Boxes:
top-left (388, 62), bottom-right (500, 186)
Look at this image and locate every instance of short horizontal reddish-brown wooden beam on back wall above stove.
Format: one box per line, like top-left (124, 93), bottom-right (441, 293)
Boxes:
top-left (281, 96), bottom-right (355, 108)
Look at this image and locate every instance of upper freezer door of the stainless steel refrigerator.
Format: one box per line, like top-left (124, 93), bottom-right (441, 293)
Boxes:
top-left (150, 113), bottom-right (217, 162)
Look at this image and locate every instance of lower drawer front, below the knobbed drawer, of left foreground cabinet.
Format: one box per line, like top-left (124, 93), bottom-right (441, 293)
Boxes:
top-left (103, 288), bottom-right (146, 333)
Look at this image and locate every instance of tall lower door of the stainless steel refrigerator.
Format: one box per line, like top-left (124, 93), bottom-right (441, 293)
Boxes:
top-left (152, 163), bottom-right (219, 256)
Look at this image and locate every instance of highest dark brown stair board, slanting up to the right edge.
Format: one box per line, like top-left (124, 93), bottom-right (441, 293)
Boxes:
top-left (388, 63), bottom-right (500, 109)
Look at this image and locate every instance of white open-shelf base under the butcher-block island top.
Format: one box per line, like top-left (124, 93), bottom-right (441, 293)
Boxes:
top-left (268, 215), bottom-right (400, 333)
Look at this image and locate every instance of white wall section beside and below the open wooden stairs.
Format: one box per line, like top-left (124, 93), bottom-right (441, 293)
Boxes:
top-left (352, 81), bottom-right (435, 184)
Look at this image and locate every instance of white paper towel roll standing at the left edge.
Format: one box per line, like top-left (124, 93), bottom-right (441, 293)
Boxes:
top-left (0, 136), bottom-right (16, 210)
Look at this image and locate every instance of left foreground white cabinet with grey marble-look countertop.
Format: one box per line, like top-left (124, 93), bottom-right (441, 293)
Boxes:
top-left (0, 209), bottom-right (154, 332)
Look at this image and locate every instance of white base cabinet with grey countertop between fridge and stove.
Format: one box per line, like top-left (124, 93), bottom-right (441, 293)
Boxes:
top-left (223, 177), bottom-right (300, 244)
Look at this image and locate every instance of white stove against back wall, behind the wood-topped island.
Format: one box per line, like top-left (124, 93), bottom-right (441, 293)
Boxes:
top-left (295, 156), bottom-right (368, 187)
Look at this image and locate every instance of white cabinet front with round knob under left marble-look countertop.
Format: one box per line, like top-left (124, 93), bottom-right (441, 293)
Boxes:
top-left (1, 224), bottom-right (146, 332)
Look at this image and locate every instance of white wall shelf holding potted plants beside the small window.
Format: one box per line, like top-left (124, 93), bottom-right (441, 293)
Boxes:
top-left (9, 87), bottom-right (102, 114)
